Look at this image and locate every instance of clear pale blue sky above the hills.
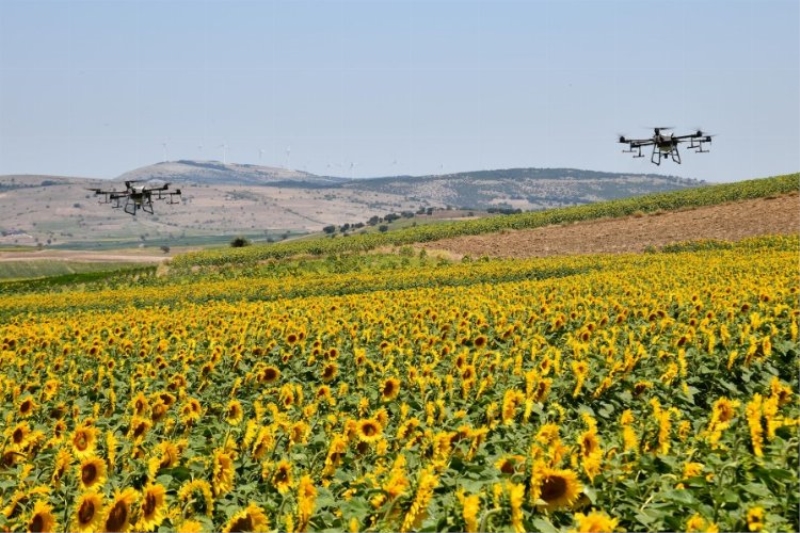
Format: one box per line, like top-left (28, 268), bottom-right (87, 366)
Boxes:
top-left (0, 0), bottom-right (800, 182)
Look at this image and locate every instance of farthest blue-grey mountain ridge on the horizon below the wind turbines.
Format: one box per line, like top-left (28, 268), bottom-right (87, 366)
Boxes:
top-left (115, 160), bottom-right (705, 210)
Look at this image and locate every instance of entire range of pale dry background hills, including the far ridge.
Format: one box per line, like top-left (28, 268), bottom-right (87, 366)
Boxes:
top-left (0, 161), bottom-right (702, 249)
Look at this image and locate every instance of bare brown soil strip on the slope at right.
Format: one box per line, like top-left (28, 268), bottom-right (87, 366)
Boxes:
top-left (425, 193), bottom-right (800, 258)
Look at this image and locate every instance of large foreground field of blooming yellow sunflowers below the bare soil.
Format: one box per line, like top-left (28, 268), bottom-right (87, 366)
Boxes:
top-left (0, 232), bottom-right (800, 532)
